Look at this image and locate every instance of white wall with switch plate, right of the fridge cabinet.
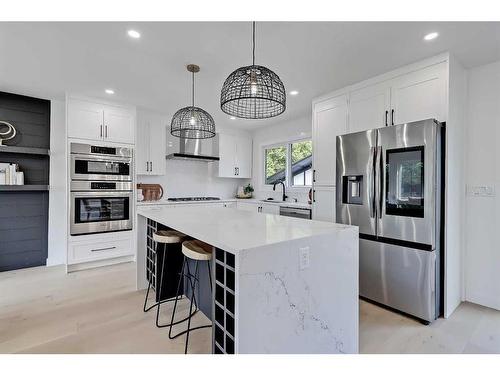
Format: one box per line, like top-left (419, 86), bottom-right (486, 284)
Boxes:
top-left (465, 61), bottom-right (500, 309)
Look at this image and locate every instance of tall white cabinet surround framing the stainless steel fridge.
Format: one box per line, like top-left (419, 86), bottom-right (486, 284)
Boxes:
top-left (312, 53), bottom-right (467, 317)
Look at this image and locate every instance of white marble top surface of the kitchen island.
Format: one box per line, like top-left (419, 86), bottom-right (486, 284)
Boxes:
top-left (137, 204), bottom-right (357, 253)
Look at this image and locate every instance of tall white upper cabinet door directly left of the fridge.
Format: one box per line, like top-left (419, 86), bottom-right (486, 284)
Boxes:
top-left (313, 95), bottom-right (347, 186)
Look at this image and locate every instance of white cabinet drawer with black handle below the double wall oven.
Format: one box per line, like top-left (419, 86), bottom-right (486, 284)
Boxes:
top-left (68, 238), bottom-right (133, 264)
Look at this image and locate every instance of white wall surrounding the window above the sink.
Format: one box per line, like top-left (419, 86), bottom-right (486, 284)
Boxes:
top-left (252, 115), bottom-right (312, 202)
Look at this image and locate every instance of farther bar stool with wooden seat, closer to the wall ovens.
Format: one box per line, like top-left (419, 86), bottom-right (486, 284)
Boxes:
top-left (143, 229), bottom-right (192, 328)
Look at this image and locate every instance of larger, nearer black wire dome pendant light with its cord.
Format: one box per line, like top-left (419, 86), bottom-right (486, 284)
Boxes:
top-left (220, 22), bottom-right (286, 119)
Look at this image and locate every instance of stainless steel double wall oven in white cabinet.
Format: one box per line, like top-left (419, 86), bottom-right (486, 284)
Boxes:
top-left (70, 143), bottom-right (134, 236)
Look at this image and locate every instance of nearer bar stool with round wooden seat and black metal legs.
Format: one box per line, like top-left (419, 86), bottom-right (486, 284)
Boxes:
top-left (168, 240), bottom-right (212, 354)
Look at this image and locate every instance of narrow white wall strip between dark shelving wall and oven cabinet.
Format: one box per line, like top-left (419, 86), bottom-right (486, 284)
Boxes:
top-left (47, 100), bottom-right (68, 266)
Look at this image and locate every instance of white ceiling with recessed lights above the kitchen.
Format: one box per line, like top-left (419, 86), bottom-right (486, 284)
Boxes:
top-left (0, 22), bottom-right (500, 130)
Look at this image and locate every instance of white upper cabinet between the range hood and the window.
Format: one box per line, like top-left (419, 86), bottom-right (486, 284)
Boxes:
top-left (217, 133), bottom-right (252, 178)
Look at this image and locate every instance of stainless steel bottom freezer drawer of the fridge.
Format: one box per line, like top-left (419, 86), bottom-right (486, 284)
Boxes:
top-left (359, 239), bottom-right (438, 321)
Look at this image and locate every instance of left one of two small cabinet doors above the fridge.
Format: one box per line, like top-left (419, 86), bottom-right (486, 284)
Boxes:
top-left (348, 83), bottom-right (391, 133)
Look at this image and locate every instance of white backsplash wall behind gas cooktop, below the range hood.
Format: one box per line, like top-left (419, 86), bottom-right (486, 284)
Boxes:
top-left (137, 125), bottom-right (251, 198)
